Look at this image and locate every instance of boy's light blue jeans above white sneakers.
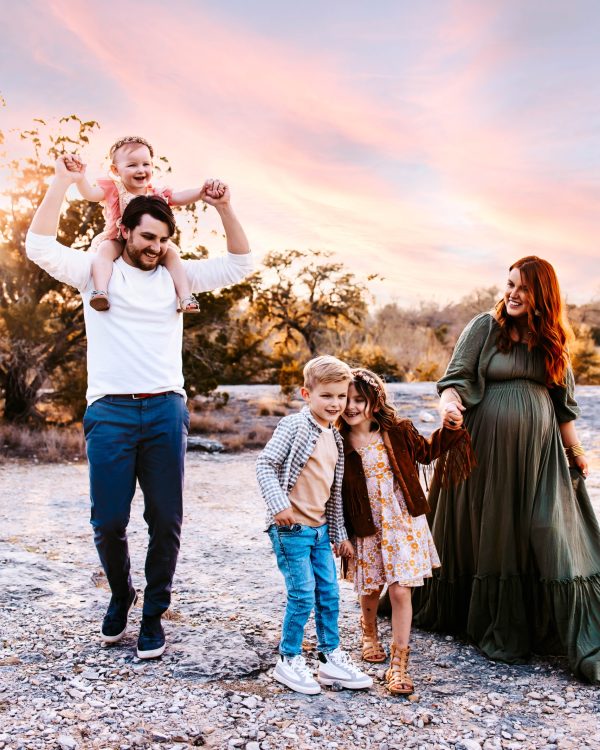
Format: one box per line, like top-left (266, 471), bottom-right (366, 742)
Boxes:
top-left (269, 524), bottom-right (340, 656)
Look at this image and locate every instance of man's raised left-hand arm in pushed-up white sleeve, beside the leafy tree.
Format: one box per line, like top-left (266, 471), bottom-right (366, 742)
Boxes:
top-left (25, 156), bottom-right (91, 289)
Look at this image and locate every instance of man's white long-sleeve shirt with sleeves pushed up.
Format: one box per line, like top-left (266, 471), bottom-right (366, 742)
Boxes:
top-left (25, 232), bottom-right (252, 404)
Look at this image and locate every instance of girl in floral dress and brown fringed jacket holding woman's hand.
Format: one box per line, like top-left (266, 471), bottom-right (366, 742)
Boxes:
top-left (340, 368), bottom-right (473, 695)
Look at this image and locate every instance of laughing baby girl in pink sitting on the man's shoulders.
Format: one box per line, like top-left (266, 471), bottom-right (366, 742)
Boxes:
top-left (66, 136), bottom-right (220, 312)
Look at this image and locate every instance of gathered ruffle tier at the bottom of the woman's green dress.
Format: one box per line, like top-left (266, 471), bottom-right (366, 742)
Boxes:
top-left (413, 574), bottom-right (600, 684)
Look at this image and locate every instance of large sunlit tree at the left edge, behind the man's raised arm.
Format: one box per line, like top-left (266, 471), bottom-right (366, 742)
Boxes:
top-left (0, 115), bottom-right (102, 422)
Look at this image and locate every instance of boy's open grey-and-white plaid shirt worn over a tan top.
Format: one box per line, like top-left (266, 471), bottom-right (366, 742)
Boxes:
top-left (256, 406), bottom-right (348, 543)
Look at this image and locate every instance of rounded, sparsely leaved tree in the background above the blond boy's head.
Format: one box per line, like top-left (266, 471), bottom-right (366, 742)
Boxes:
top-left (250, 250), bottom-right (377, 357)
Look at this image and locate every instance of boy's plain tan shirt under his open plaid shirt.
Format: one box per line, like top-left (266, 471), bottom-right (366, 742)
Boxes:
top-left (290, 430), bottom-right (338, 526)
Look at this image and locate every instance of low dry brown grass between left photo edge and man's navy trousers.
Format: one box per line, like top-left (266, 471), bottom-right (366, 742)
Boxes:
top-left (0, 424), bottom-right (85, 463)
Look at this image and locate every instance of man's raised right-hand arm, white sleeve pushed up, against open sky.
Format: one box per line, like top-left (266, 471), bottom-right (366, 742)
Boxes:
top-left (184, 180), bottom-right (252, 292)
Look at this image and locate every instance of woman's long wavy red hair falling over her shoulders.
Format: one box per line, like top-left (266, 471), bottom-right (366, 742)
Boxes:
top-left (496, 255), bottom-right (573, 387)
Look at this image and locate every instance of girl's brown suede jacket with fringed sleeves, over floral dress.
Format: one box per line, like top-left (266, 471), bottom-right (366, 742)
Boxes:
top-left (342, 419), bottom-right (475, 537)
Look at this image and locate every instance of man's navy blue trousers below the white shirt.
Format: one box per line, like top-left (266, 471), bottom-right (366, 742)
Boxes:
top-left (83, 393), bottom-right (189, 615)
